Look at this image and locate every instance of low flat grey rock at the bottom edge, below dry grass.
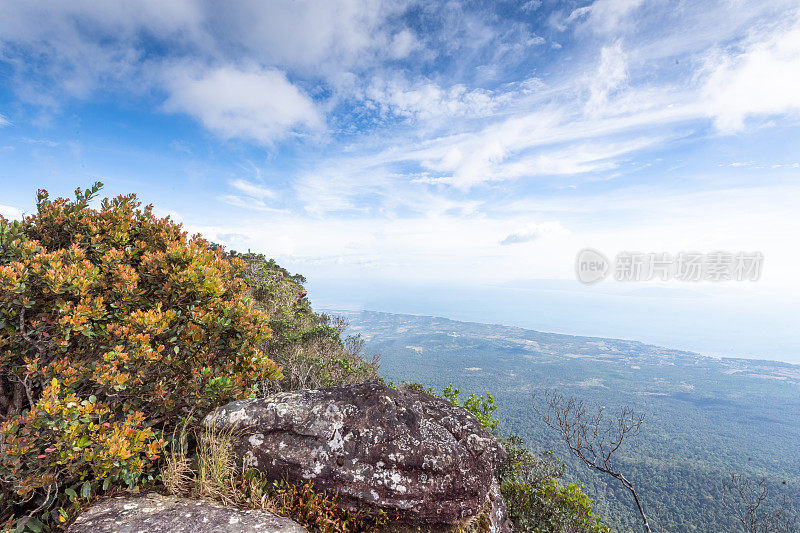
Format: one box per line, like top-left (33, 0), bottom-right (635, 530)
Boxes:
top-left (67, 493), bottom-right (306, 533)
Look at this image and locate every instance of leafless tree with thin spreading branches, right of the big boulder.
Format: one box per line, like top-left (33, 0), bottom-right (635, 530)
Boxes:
top-left (534, 390), bottom-right (651, 533)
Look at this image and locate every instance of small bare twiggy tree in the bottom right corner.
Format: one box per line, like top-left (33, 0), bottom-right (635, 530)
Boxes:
top-left (722, 474), bottom-right (798, 533)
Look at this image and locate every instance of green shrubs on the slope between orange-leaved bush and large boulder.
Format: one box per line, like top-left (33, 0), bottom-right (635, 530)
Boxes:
top-left (230, 252), bottom-right (378, 392)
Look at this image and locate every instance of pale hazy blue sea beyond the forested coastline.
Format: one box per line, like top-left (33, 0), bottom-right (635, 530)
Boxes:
top-left (308, 279), bottom-right (800, 364)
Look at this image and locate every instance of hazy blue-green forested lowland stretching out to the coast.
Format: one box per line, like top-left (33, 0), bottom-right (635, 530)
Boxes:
top-left (331, 311), bottom-right (800, 531)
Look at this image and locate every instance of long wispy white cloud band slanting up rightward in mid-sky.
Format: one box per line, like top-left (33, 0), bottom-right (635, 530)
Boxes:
top-left (381, 101), bottom-right (688, 189)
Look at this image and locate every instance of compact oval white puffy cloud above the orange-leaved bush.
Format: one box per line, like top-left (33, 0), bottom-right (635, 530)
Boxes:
top-left (164, 66), bottom-right (323, 144)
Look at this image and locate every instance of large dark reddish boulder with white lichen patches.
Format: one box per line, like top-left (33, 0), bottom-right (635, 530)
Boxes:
top-left (203, 382), bottom-right (505, 524)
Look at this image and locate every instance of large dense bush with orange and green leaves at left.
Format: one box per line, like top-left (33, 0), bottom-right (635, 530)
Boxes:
top-left (0, 183), bottom-right (281, 531)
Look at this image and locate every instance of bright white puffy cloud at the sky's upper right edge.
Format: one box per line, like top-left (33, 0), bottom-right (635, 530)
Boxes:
top-left (703, 12), bottom-right (800, 133)
